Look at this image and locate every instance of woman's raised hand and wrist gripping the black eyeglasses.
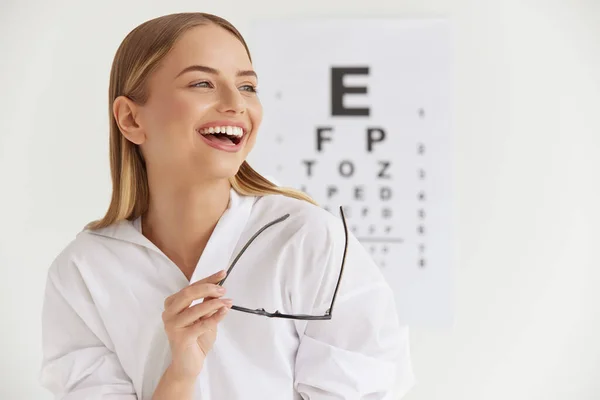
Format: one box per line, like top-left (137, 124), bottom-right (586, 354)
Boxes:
top-left (162, 271), bottom-right (232, 382)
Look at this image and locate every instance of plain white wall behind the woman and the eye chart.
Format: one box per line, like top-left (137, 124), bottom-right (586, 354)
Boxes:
top-left (0, 0), bottom-right (600, 400)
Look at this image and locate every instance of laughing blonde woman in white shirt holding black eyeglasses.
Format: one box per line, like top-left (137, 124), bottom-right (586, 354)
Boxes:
top-left (41, 13), bottom-right (413, 400)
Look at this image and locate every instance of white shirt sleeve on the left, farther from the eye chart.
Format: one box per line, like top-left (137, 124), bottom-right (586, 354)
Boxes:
top-left (40, 255), bottom-right (137, 400)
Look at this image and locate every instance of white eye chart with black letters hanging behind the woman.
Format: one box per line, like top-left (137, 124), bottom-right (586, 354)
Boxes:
top-left (248, 19), bottom-right (453, 326)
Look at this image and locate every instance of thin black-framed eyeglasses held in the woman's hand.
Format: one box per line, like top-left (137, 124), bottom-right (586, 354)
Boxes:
top-left (218, 207), bottom-right (348, 320)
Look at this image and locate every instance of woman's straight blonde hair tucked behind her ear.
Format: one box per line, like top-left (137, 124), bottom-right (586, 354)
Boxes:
top-left (87, 13), bottom-right (316, 229)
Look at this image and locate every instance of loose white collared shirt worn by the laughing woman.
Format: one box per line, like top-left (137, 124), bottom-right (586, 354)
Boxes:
top-left (41, 190), bottom-right (414, 400)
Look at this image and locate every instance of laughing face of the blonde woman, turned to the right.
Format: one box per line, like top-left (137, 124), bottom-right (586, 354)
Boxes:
top-left (138, 24), bottom-right (262, 181)
